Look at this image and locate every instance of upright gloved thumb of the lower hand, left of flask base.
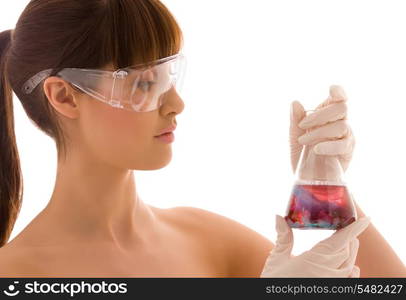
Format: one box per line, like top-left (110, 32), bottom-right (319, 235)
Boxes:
top-left (270, 215), bottom-right (293, 259)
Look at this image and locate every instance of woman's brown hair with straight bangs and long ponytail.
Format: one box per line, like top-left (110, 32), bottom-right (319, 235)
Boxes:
top-left (0, 0), bottom-right (183, 247)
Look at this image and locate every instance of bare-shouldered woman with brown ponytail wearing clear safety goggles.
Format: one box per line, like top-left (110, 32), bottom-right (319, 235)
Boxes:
top-left (0, 0), bottom-right (405, 277)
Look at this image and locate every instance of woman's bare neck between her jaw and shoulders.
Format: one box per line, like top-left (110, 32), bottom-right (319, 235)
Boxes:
top-left (41, 149), bottom-right (155, 247)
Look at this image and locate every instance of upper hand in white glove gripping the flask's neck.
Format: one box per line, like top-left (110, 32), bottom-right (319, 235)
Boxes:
top-left (289, 85), bottom-right (355, 172)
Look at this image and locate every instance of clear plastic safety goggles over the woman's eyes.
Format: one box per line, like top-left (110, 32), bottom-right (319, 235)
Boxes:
top-left (22, 53), bottom-right (186, 112)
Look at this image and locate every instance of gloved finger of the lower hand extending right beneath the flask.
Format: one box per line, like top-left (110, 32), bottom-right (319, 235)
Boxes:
top-left (310, 217), bottom-right (371, 254)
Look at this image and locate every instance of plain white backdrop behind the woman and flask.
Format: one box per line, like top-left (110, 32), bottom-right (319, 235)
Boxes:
top-left (0, 0), bottom-right (406, 262)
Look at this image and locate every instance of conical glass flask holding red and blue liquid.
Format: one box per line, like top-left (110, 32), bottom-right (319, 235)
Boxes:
top-left (285, 110), bottom-right (357, 230)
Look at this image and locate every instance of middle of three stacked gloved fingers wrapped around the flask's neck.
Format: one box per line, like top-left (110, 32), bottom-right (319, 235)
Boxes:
top-left (298, 120), bottom-right (349, 145)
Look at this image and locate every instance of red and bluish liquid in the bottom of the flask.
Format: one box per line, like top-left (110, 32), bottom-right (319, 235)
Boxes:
top-left (285, 185), bottom-right (356, 230)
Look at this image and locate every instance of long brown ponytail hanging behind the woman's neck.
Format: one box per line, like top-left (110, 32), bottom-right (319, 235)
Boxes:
top-left (0, 30), bottom-right (23, 247)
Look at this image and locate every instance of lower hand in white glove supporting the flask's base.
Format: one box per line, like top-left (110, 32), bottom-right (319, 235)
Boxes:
top-left (260, 215), bottom-right (370, 277)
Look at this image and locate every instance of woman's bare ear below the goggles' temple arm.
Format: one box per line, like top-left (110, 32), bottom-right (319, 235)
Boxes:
top-left (44, 76), bottom-right (79, 119)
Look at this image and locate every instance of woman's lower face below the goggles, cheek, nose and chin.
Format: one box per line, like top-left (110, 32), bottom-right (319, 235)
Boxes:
top-left (73, 63), bottom-right (184, 170)
